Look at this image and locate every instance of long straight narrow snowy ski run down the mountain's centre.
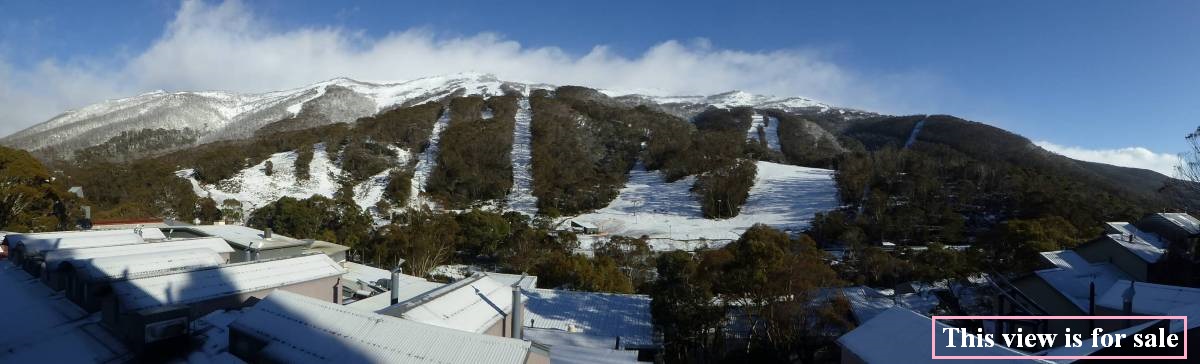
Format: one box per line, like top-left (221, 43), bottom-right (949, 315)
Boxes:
top-left (506, 99), bottom-right (538, 215)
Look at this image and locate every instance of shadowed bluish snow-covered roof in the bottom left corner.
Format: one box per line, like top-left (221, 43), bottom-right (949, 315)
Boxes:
top-left (0, 264), bottom-right (128, 363)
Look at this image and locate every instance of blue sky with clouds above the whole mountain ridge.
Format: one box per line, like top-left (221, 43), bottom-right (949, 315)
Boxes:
top-left (0, 0), bottom-right (1200, 174)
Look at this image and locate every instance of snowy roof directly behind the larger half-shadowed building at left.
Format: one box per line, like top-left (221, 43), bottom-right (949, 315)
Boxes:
top-left (79, 247), bottom-right (224, 281)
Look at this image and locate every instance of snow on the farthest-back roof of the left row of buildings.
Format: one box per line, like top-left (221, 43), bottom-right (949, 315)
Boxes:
top-left (5, 228), bottom-right (166, 256)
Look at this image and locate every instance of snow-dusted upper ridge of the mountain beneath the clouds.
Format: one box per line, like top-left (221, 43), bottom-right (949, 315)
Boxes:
top-left (0, 73), bottom-right (852, 157)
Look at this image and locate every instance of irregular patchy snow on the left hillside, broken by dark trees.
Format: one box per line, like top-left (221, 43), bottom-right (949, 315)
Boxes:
top-left (175, 144), bottom-right (408, 213)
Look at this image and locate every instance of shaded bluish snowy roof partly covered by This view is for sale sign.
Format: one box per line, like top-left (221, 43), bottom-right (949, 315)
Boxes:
top-left (838, 308), bottom-right (1048, 364)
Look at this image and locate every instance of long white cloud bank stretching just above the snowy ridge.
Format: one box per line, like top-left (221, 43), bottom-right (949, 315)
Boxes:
top-left (0, 1), bottom-right (938, 135)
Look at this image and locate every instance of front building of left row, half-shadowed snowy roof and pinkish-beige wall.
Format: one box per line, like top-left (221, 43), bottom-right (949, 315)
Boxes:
top-left (102, 255), bottom-right (343, 351)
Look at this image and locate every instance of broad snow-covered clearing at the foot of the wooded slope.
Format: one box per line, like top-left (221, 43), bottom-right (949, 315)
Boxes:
top-left (568, 162), bottom-right (838, 250)
